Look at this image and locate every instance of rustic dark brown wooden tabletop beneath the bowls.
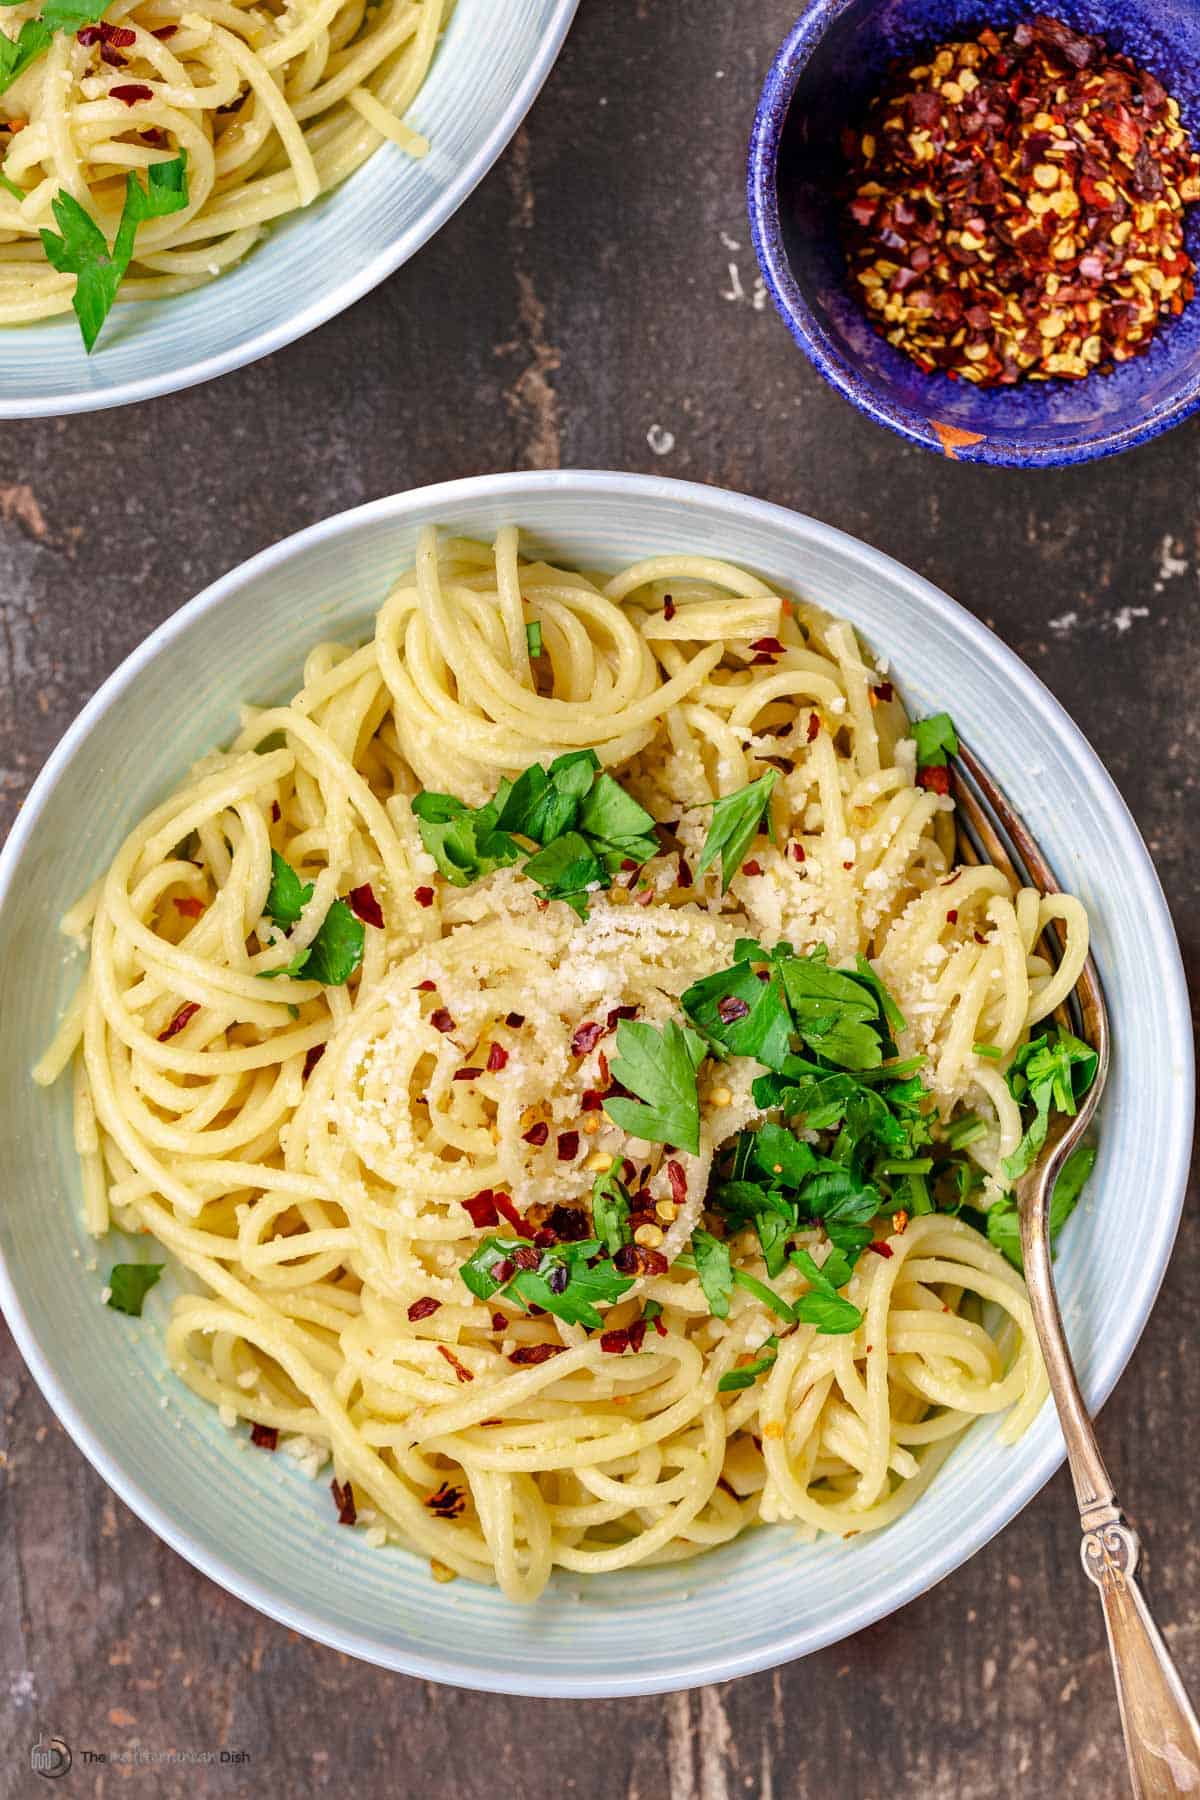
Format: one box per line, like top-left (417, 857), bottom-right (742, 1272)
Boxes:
top-left (0, 0), bottom-right (1200, 1800)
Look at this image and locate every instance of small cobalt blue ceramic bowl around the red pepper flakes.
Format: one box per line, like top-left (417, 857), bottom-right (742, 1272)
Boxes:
top-left (748, 0), bottom-right (1200, 468)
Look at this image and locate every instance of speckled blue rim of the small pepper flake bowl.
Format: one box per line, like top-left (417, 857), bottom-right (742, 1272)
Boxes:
top-left (747, 0), bottom-right (1200, 468)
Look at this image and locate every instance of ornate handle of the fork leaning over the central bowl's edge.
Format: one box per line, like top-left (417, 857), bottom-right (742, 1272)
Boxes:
top-left (1020, 1134), bottom-right (1200, 1800)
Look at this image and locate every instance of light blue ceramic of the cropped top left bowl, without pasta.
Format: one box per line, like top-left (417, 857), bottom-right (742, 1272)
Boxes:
top-left (0, 0), bottom-right (579, 419)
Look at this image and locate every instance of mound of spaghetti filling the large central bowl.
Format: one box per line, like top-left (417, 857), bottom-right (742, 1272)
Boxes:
top-left (36, 527), bottom-right (1087, 1600)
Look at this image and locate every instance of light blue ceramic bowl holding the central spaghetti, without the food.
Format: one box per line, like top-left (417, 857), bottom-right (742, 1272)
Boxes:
top-left (0, 472), bottom-right (1193, 1696)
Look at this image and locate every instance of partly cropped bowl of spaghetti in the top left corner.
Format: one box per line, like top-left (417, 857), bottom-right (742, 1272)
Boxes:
top-left (0, 0), bottom-right (576, 418)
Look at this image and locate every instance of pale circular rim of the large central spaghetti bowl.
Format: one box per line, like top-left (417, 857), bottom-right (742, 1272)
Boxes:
top-left (0, 468), bottom-right (1195, 1699)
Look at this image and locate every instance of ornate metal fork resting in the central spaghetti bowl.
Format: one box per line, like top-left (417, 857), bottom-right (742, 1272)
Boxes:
top-left (950, 743), bottom-right (1200, 1800)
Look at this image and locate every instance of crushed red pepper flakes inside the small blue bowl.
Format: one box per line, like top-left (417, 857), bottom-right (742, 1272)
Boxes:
top-left (844, 13), bottom-right (1200, 387)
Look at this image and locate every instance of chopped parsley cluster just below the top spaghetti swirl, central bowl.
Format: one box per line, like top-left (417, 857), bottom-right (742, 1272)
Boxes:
top-left (412, 751), bottom-right (658, 918)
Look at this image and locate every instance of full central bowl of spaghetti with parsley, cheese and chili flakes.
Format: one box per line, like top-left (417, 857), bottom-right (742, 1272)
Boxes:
top-left (0, 472), bottom-right (1191, 1696)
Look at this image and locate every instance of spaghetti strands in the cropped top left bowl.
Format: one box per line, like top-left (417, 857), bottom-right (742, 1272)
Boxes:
top-left (0, 0), bottom-right (450, 324)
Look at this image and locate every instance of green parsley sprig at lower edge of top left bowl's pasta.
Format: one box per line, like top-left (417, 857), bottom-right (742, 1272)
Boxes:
top-left (41, 153), bottom-right (187, 355)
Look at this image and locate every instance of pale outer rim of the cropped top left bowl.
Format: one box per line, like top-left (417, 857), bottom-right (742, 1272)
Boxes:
top-left (0, 0), bottom-right (579, 419)
